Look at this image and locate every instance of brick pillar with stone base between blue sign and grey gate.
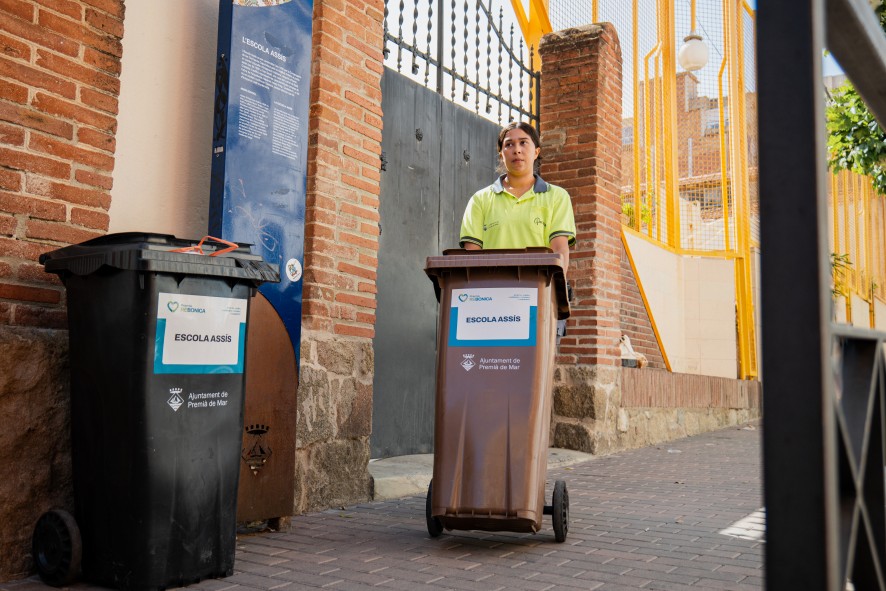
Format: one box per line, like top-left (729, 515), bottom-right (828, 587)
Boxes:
top-left (293, 0), bottom-right (384, 513)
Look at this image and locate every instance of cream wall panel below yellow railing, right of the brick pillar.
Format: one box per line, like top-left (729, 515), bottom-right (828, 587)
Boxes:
top-left (625, 233), bottom-right (738, 378)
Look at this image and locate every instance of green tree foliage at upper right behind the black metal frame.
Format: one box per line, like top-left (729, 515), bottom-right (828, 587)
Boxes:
top-left (827, 2), bottom-right (886, 195)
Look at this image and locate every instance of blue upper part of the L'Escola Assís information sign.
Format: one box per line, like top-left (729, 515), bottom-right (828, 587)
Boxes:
top-left (209, 0), bottom-right (313, 363)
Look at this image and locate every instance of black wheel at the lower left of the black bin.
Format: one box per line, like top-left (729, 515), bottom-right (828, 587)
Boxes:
top-left (31, 509), bottom-right (83, 587)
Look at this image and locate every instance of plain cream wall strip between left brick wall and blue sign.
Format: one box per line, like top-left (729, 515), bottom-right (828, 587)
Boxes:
top-left (110, 0), bottom-right (218, 238)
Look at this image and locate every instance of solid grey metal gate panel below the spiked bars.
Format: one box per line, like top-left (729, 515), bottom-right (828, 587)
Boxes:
top-left (371, 69), bottom-right (500, 458)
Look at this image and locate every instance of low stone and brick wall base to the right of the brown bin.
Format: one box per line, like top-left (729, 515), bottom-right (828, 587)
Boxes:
top-left (551, 366), bottom-right (762, 455)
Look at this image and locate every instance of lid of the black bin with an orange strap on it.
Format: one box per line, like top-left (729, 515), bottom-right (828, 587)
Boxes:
top-left (40, 232), bottom-right (280, 286)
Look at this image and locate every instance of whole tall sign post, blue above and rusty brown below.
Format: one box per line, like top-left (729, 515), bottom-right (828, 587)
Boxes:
top-left (209, 0), bottom-right (313, 526)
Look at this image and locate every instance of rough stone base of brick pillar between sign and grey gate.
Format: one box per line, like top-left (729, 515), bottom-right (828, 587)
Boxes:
top-left (293, 331), bottom-right (374, 514)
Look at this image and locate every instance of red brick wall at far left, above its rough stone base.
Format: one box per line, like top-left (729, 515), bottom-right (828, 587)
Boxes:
top-left (0, 0), bottom-right (124, 328)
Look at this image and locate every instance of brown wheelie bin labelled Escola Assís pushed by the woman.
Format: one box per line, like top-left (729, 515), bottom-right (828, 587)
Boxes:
top-left (425, 248), bottom-right (569, 542)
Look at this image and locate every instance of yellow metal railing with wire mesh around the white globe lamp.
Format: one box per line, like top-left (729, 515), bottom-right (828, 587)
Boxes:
top-left (511, 0), bottom-right (764, 378)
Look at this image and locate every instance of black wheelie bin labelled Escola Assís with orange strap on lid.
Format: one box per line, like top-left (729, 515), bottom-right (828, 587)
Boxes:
top-left (33, 233), bottom-right (279, 590)
